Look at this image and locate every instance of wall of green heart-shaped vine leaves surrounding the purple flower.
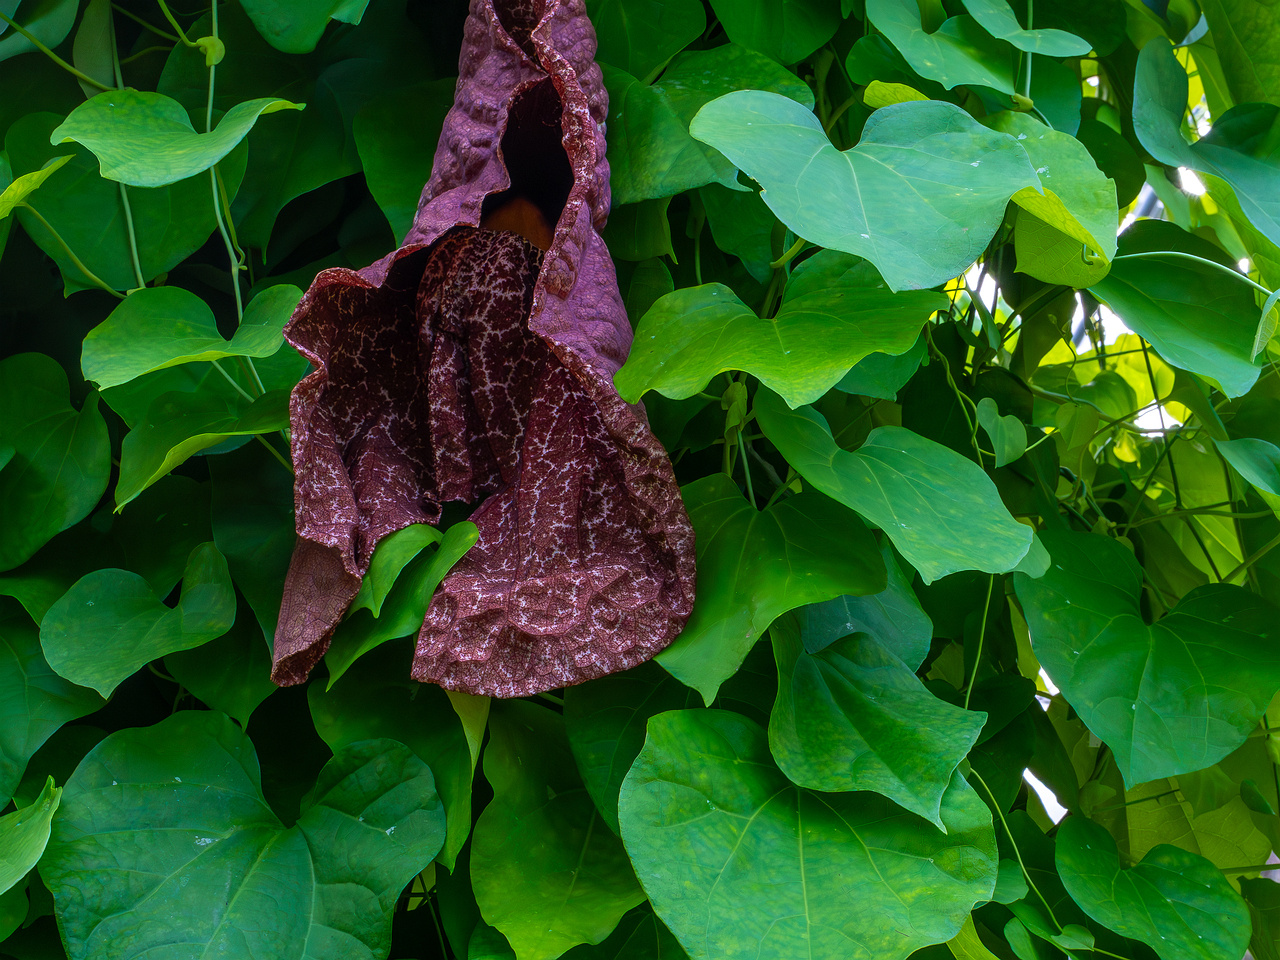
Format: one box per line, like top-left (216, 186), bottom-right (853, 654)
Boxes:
top-left (0, 0), bottom-right (1280, 960)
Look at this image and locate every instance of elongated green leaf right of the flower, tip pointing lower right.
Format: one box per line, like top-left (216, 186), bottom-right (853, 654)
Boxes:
top-left (755, 389), bottom-right (1032, 584)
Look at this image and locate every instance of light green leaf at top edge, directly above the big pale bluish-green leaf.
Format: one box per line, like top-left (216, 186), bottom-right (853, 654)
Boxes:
top-left (867, 0), bottom-right (1016, 96)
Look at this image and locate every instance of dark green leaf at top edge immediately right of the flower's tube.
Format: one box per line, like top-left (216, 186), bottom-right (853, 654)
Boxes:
top-left (586, 0), bottom-right (706, 83)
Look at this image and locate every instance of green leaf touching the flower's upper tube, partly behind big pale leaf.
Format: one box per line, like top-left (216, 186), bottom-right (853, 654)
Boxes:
top-left (604, 44), bottom-right (814, 205)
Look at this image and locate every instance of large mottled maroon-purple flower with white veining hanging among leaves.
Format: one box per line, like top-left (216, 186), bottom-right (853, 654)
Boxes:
top-left (263, 0), bottom-right (694, 696)
